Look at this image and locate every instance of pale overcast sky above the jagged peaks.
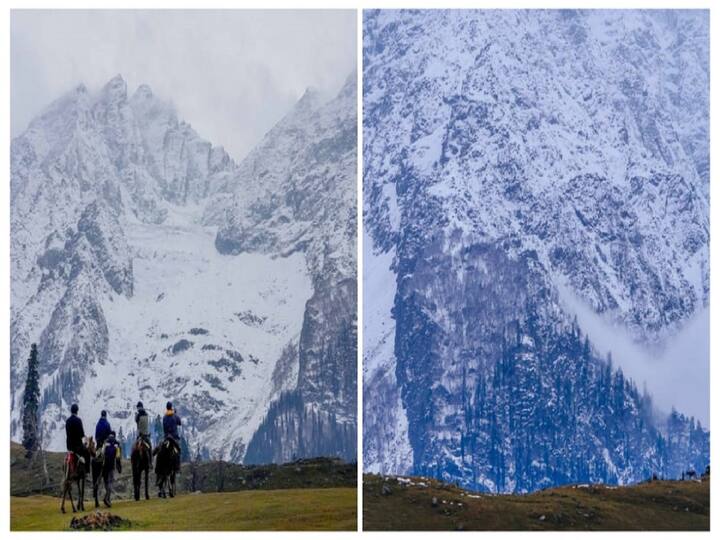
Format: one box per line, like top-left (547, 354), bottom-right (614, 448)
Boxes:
top-left (10, 10), bottom-right (356, 160)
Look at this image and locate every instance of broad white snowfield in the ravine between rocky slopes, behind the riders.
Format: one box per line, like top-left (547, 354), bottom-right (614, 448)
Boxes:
top-left (43, 205), bottom-right (312, 458)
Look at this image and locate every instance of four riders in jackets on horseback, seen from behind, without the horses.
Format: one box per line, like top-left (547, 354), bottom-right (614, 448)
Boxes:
top-left (65, 401), bottom-right (182, 506)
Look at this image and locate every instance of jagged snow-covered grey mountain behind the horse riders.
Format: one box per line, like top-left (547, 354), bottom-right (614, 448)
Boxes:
top-left (11, 71), bottom-right (356, 461)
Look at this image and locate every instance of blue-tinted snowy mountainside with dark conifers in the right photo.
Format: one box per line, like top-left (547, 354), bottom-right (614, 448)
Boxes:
top-left (363, 10), bottom-right (709, 491)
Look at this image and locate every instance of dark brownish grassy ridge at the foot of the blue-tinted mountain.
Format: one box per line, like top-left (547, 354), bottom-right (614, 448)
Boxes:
top-left (363, 475), bottom-right (710, 531)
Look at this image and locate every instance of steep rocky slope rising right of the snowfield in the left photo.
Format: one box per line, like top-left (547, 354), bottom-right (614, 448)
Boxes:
top-left (228, 75), bottom-right (357, 462)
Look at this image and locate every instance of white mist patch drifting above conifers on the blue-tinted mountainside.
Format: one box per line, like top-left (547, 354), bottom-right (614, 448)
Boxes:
top-left (558, 285), bottom-right (710, 428)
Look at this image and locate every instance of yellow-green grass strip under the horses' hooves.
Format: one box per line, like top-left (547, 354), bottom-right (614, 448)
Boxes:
top-left (10, 488), bottom-right (357, 531)
